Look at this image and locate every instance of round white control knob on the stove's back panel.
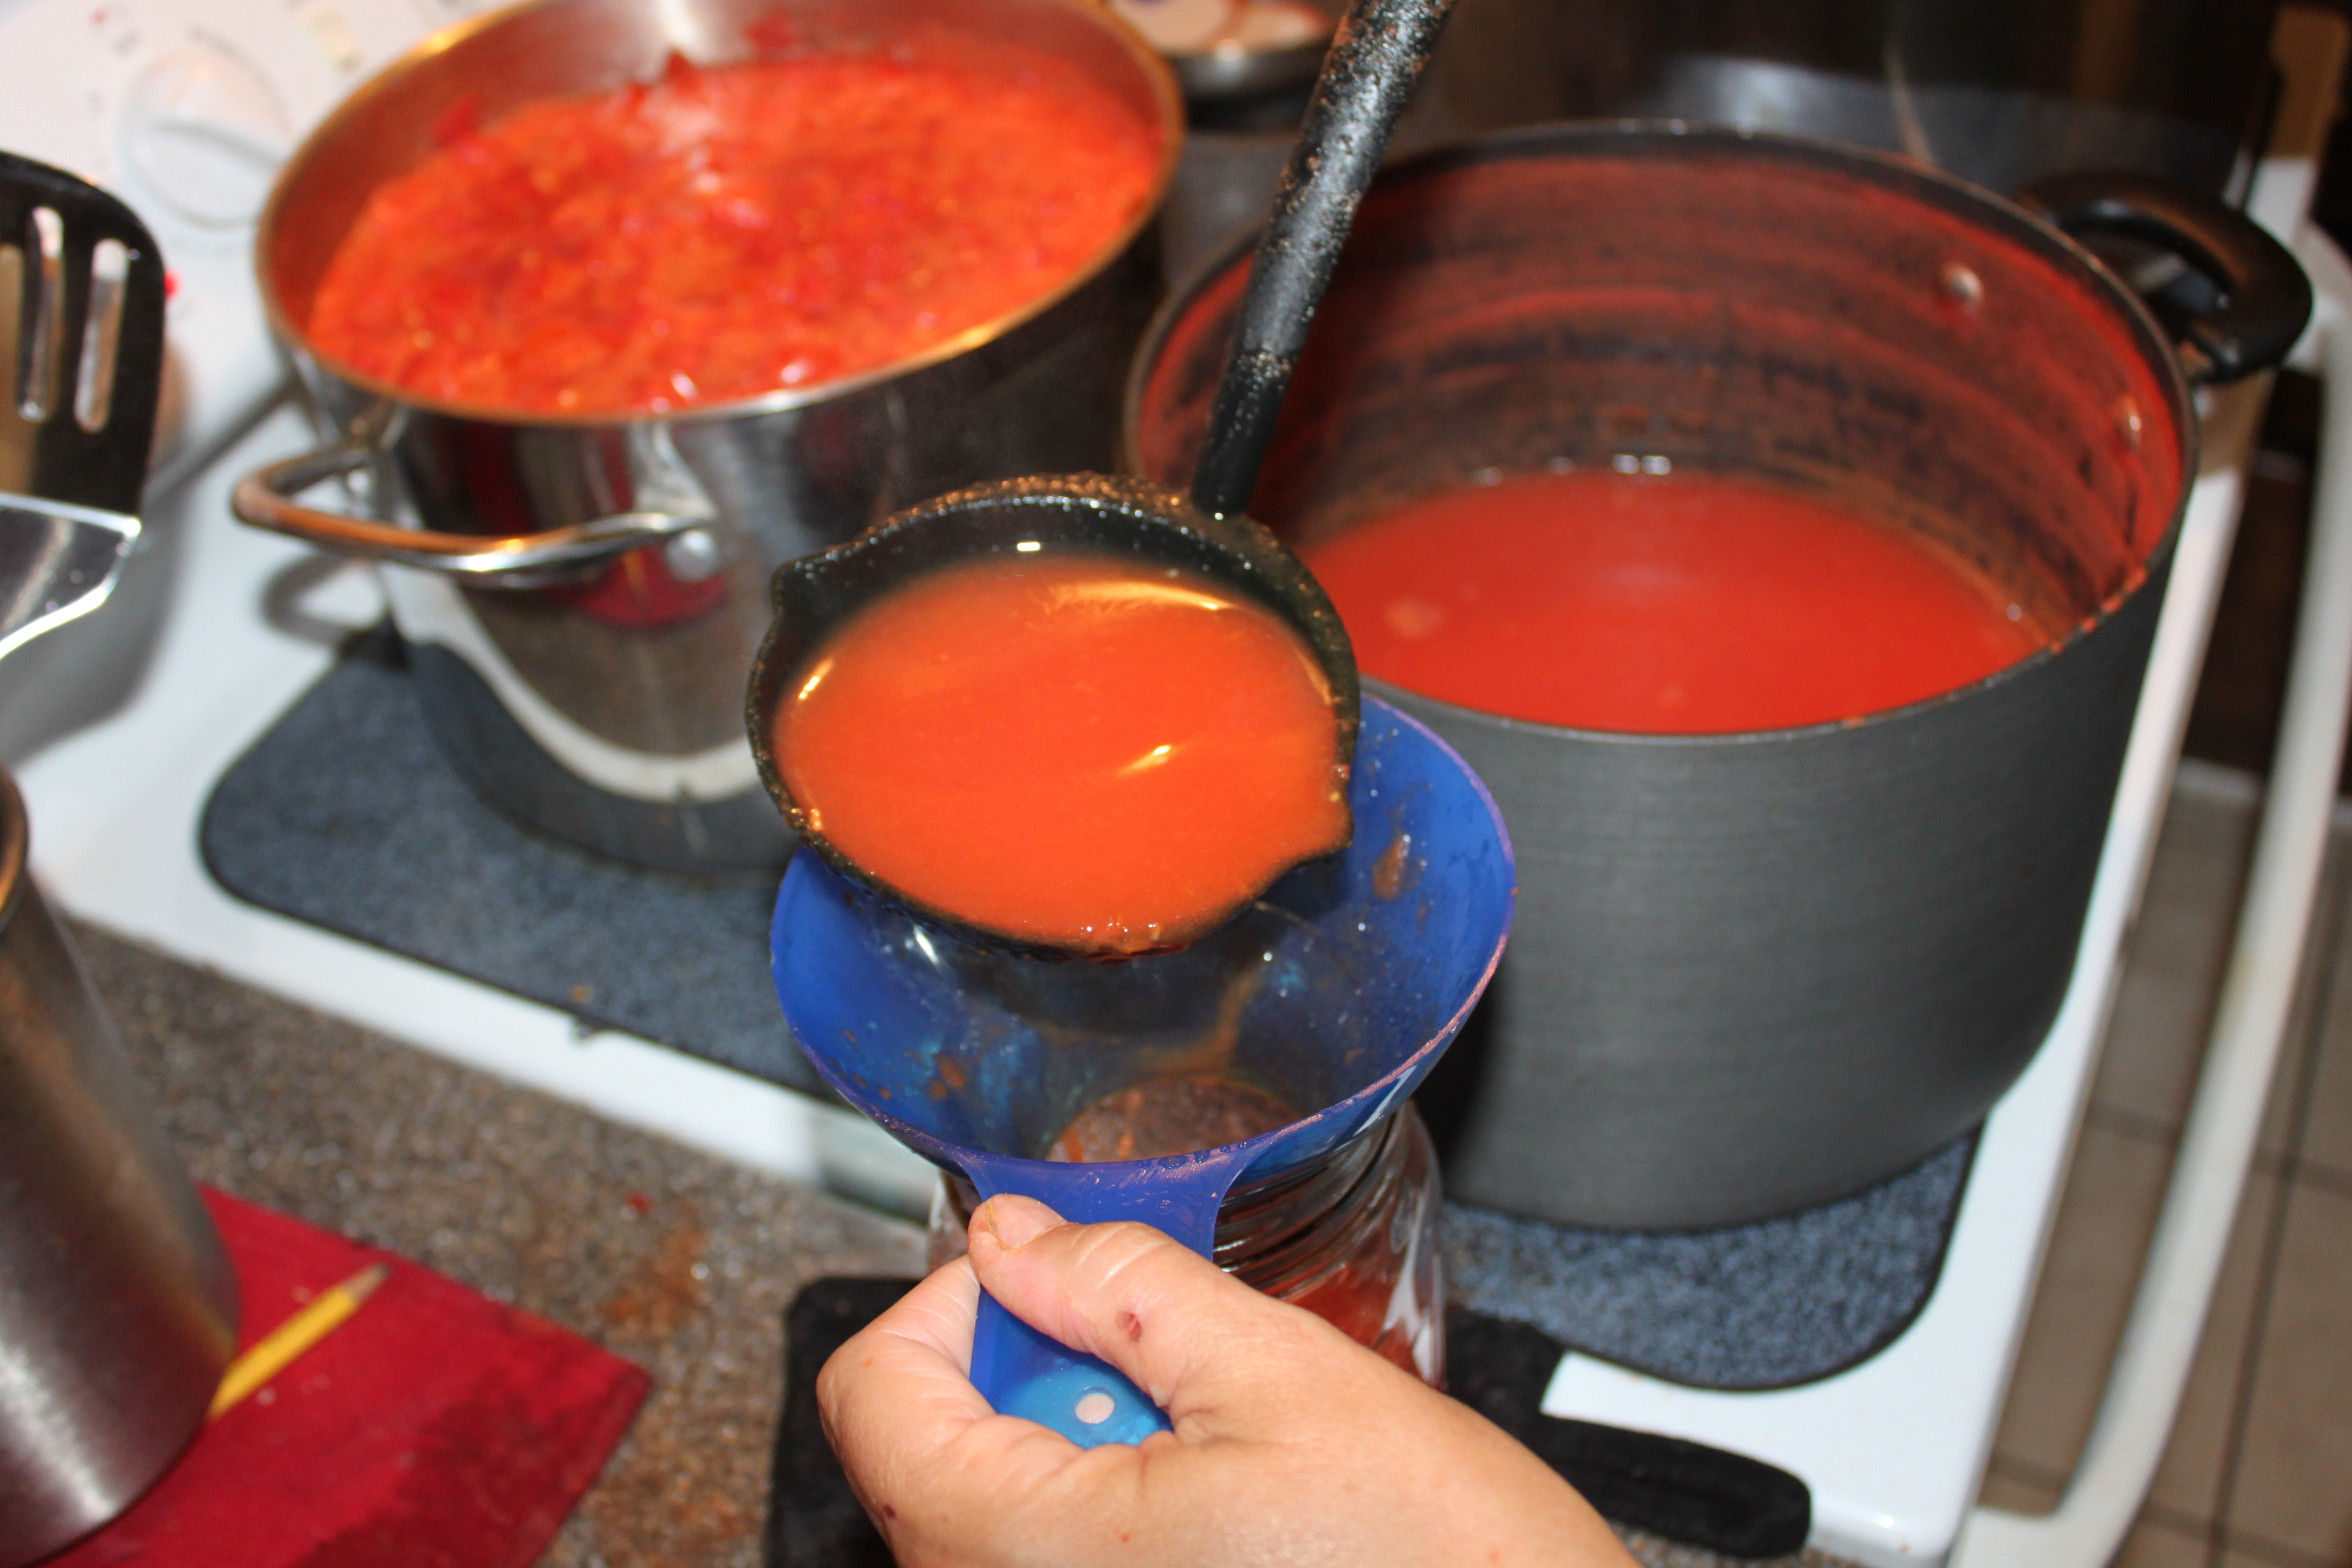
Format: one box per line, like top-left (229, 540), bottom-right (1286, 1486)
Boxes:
top-left (122, 45), bottom-right (292, 228)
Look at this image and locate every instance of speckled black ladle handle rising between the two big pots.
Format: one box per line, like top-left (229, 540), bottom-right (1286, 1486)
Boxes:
top-left (1192, 0), bottom-right (1454, 517)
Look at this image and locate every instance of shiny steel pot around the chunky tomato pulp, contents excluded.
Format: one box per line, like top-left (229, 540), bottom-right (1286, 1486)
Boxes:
top-left (235, 0), bottom-right (1183, 872)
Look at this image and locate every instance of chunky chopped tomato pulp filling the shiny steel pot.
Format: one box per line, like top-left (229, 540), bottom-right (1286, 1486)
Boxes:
top-left (308, 49), bottom-right (1160, 414)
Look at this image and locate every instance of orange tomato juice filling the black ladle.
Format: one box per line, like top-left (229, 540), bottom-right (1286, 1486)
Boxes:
top-left (774, 552), bottom-right (1348, 954)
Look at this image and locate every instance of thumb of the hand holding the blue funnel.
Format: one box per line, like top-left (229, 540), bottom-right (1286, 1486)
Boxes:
top-left (971, 1197), bottom-right (1352, 1436)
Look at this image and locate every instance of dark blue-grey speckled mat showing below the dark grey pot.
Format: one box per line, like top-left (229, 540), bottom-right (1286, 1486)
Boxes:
top-left (1444, 1133), bottom-right (1976, 1389)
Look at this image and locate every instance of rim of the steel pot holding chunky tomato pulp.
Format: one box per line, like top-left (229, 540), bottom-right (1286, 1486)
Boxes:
top-left (254, 0), bottom-right (1185, 430)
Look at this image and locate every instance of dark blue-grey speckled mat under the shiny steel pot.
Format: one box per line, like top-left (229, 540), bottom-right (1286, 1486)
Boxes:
top-left (200, 632), bottom-right (823, 1093)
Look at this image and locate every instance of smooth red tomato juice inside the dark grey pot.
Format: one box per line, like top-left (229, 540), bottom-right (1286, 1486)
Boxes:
top-left (1308, 463), bottom-right (2053, 736)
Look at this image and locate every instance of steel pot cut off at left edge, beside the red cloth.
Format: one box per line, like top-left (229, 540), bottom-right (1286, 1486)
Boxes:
top-left (0, 773), bottom-right (238, 1568)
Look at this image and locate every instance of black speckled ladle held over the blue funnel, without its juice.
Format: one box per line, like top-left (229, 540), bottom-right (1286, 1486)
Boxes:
top-left (746, 0), bottom-right (1454, 957)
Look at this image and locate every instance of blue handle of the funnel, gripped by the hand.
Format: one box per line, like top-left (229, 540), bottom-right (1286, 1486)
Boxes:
top-left (964, 1145), bottom-right (1247, 1448)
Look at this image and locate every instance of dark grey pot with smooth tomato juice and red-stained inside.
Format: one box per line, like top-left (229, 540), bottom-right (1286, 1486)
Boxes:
top-left (1127, 125), bottom-right (2293, 1227)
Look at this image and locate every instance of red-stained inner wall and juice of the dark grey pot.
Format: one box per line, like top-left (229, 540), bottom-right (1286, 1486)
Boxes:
top-left (1129, 139), bottom-right (2178, 736)
